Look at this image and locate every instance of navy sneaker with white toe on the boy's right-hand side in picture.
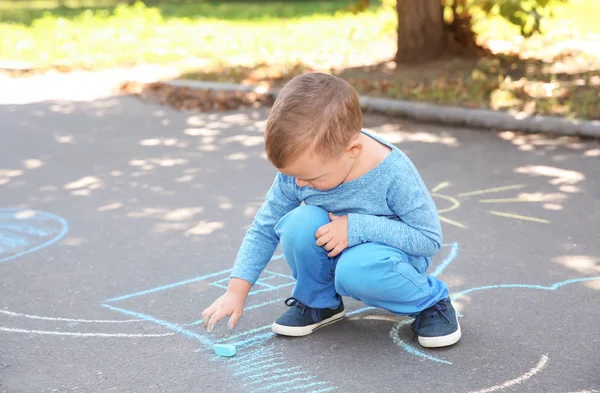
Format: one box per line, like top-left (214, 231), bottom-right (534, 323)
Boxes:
top-left (410, 298), bottom-right (461, 348)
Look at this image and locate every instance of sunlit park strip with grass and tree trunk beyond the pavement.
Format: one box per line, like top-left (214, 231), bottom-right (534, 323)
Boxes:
top-left (0, 0), bottom-right (600, 119)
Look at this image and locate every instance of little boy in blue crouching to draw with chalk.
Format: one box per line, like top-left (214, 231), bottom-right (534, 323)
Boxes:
top-left (202, 73), bottom-right (461, 347)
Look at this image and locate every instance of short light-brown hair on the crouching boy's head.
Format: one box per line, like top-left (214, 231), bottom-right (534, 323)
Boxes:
top-left (265, 72), bottom-right (362, 168)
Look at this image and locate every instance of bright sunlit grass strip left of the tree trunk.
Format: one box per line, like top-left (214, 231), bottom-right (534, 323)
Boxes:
top-left (0, 0), bottom-right (393, 68)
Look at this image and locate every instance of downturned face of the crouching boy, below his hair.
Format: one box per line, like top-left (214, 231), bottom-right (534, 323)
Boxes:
top-left (279, 145), bottom-right (356, 191)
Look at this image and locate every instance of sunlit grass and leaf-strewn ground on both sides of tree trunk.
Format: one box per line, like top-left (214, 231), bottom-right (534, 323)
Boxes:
top-left (0, 0), bottom-right (600, 119)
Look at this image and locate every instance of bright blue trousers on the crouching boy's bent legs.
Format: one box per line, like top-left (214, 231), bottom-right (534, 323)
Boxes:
top-left (275, 205), bottom-right (448, 316)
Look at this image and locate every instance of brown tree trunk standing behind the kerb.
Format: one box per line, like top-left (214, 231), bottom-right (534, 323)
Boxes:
top-left (395, 0), bottom-right (447, 63)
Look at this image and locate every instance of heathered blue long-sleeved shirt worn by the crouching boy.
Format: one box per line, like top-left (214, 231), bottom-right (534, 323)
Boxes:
top-left (231, 131), bottom-right (442, 284)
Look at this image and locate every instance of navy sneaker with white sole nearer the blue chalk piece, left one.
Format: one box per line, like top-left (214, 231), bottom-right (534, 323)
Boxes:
top-left (272, 297), bottom-right (346, 337)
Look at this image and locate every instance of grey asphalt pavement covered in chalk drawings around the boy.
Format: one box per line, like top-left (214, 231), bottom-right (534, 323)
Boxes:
top-left (0, 85), bottom-right (600, 393)
